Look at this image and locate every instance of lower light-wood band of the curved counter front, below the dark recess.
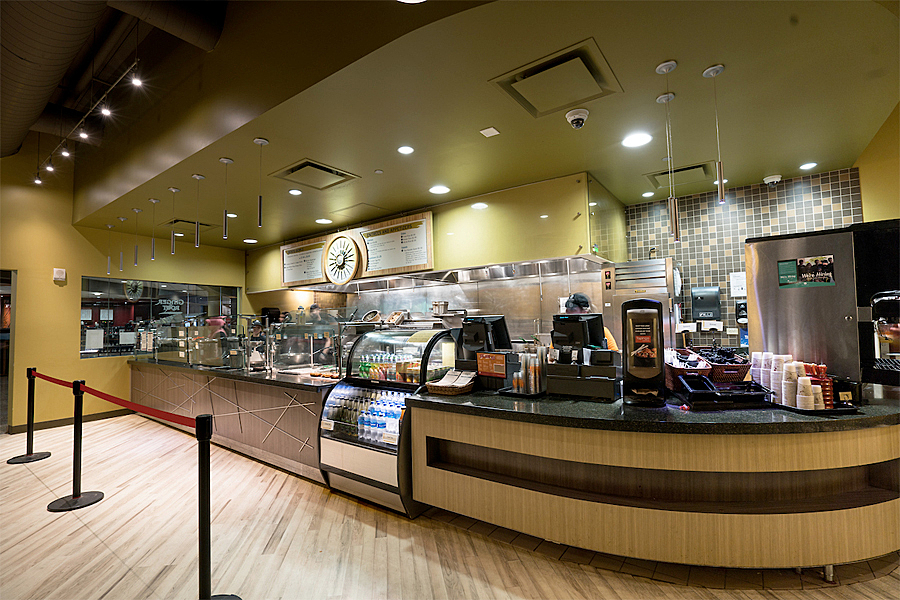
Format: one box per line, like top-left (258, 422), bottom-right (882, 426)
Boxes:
top-left (413, 462), bottom-right (900, 568)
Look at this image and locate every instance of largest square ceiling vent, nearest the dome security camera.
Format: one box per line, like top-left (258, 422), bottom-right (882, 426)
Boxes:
top-left (491, 38), bottom-right (622, 118)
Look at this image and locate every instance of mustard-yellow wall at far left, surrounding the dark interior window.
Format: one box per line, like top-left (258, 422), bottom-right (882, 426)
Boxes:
top-left (0, 134), bottom-right (247, 427)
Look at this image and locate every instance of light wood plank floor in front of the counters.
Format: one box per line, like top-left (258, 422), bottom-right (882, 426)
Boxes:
top-left (0, 415), bottom-right (900, 600)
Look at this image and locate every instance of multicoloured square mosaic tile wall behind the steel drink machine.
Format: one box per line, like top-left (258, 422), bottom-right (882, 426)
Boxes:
top-left (625, 168), bottom-right (863, 346)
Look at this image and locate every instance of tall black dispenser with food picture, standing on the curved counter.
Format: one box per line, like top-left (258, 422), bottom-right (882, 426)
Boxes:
top-left (622, 298), bottom-right (666, 406)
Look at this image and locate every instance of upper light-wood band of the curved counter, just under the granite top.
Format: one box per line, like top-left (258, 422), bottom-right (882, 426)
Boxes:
top-left (412, 408), bottom-right (900, 473)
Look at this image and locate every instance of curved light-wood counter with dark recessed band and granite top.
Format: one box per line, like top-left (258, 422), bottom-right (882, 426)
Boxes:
top-left (407, 392), bottom-right (900, 568)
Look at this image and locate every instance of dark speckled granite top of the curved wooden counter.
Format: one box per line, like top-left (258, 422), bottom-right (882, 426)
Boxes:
top-left (406, 391), bottom-right (900, 434)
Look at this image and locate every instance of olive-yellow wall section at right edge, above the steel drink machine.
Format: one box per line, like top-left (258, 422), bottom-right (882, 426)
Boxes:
top-left (853, 104), bottom-right (900, 221)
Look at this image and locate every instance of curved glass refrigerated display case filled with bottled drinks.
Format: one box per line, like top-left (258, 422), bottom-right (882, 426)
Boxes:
top-left (319, 329), bottom-right (456, 517)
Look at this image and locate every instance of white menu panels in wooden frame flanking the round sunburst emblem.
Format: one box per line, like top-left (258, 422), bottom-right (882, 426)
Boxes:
top-left (281, 212), bottom-right (434, 287)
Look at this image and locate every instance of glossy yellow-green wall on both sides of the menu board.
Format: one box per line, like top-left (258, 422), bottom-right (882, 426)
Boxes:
top-left (247, 173), bottom-right (596, 292)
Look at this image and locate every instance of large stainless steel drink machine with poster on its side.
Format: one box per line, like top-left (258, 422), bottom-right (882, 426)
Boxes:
top-left (744, 219), bottom-right (900, 386)
